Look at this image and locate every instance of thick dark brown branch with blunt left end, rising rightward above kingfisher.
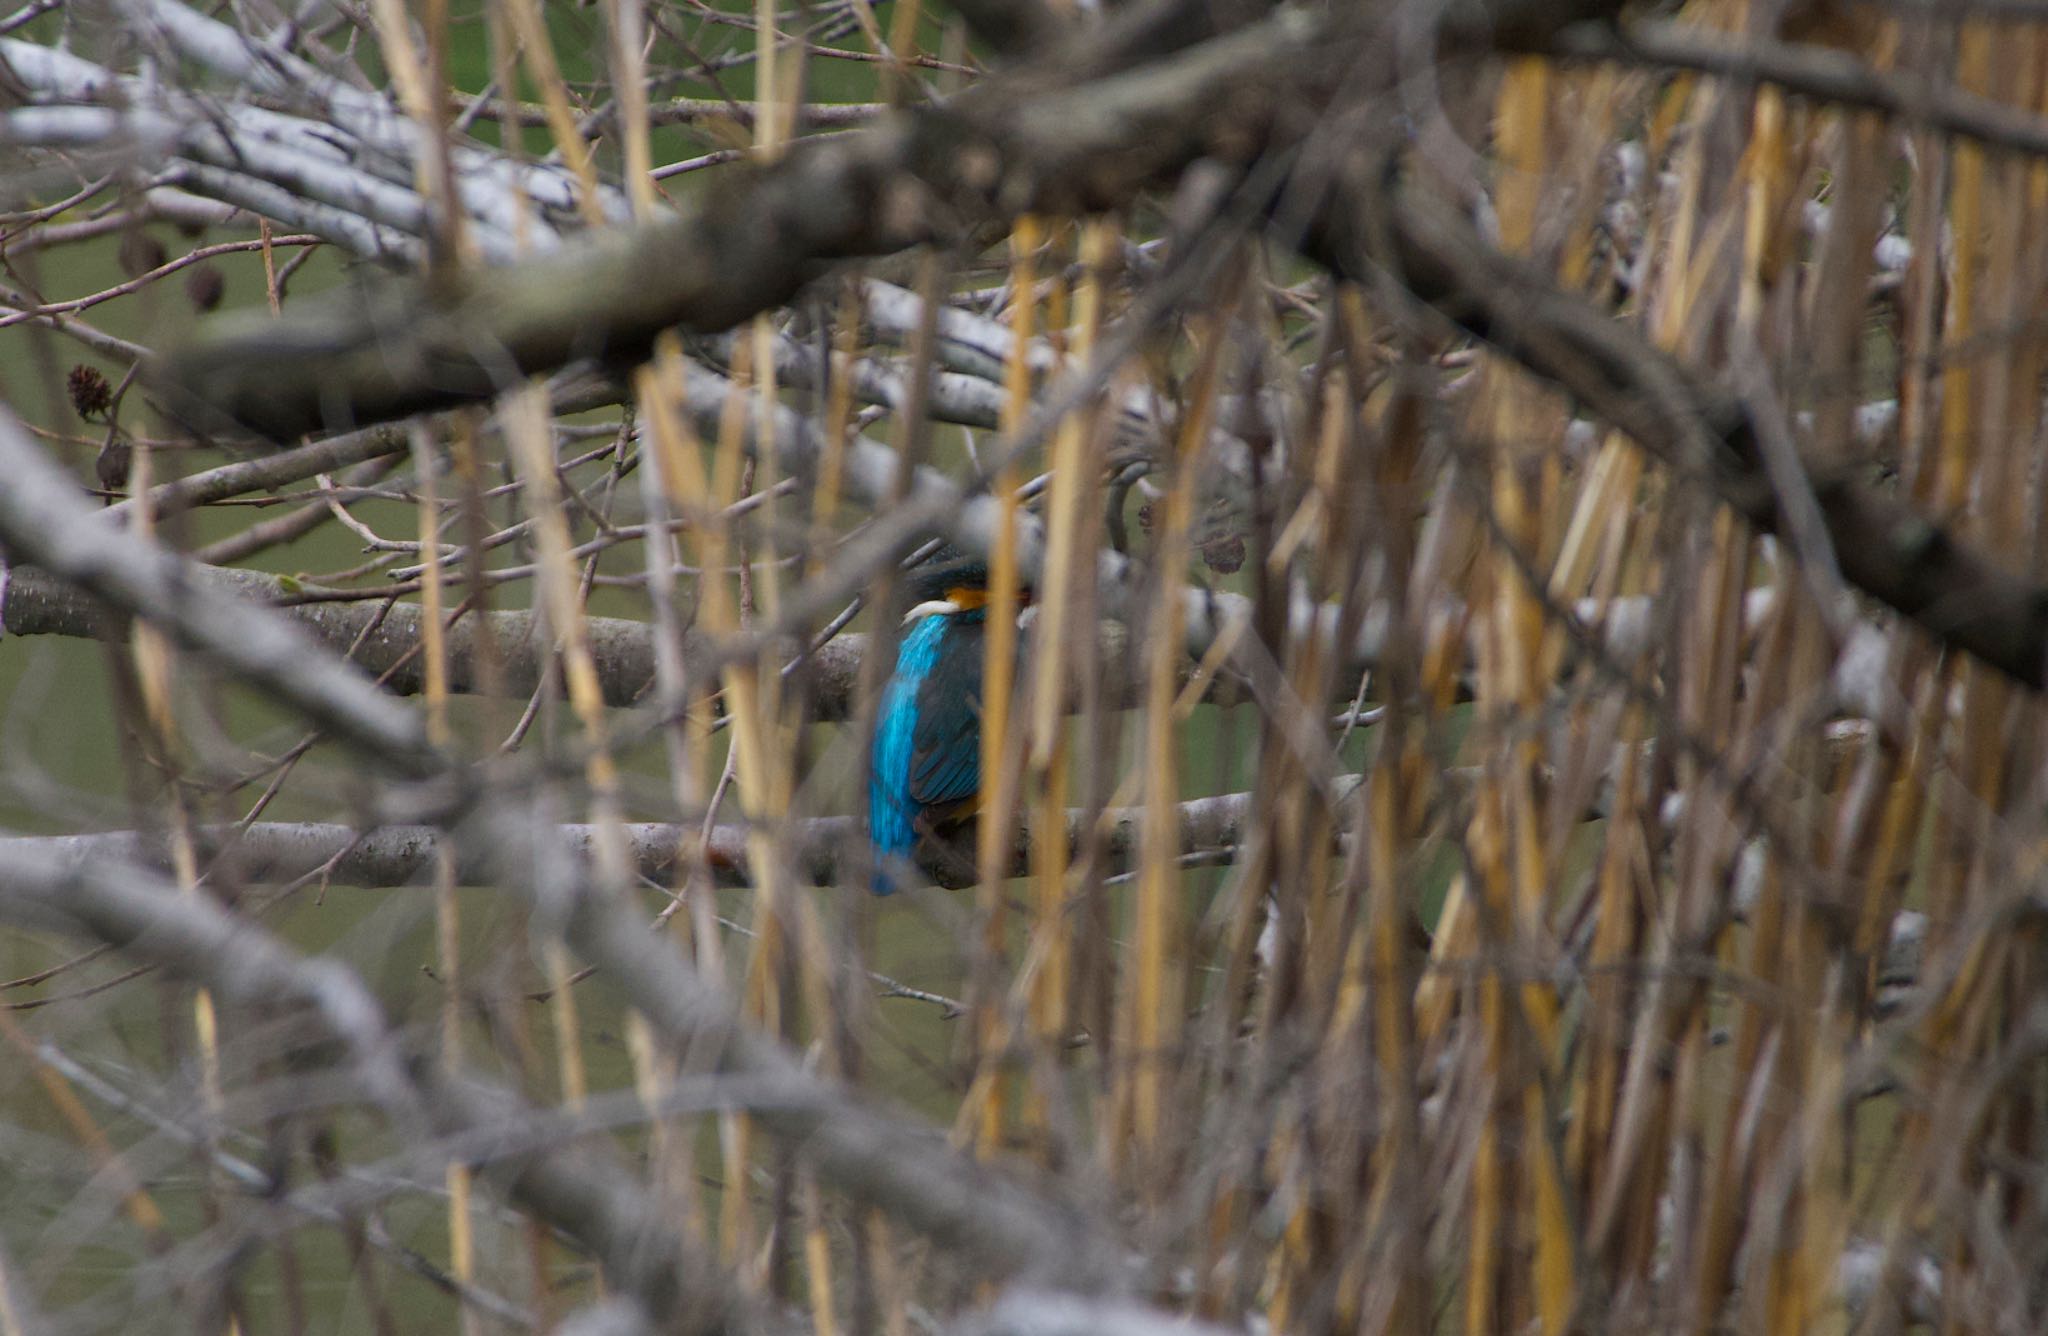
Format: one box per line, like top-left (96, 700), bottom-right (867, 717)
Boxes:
top-left (158, 0), bottom-right (1618, 441)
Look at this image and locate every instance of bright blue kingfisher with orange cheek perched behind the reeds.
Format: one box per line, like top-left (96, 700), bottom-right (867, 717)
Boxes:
top-left (868, 549), bottom-right (1015, 895)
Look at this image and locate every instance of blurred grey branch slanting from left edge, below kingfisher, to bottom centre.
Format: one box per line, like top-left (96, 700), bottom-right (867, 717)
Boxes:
top-left (0, 409), bottom-right (1122, 1289)
